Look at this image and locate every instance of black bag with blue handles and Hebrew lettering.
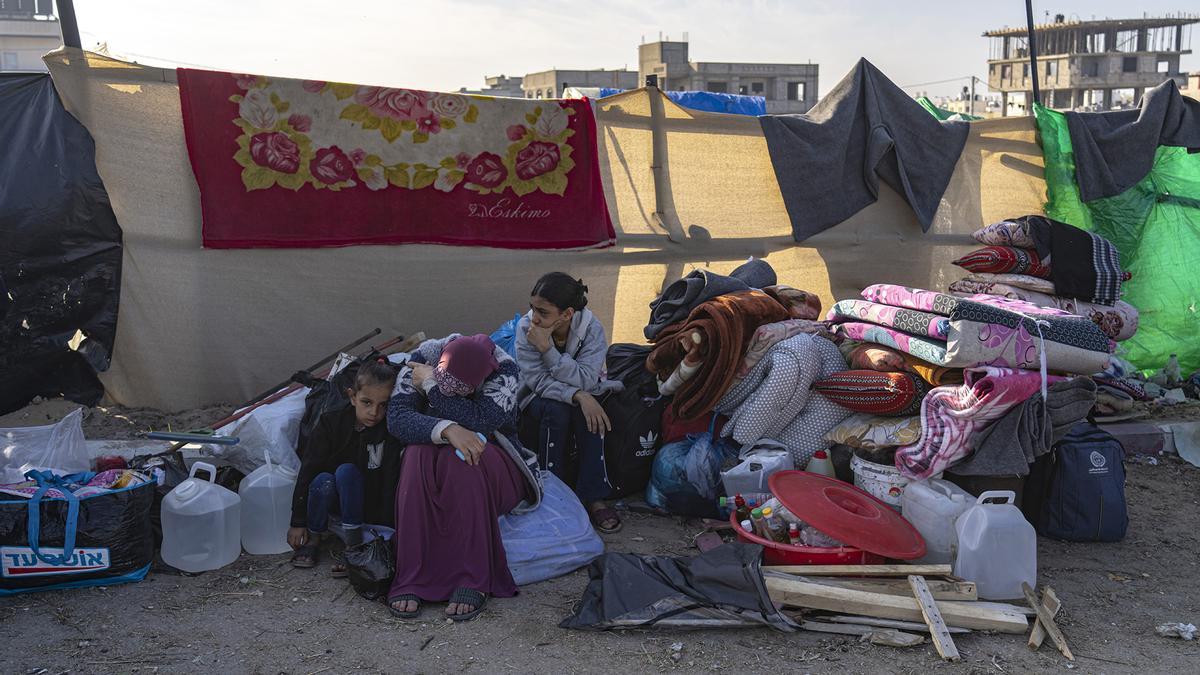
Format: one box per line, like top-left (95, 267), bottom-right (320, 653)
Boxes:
top-left (0, 470), bottom-right (155, 597)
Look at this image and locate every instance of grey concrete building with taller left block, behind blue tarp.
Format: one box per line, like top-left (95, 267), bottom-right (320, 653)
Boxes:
top-left (637, 40), bottom-right (818, 114)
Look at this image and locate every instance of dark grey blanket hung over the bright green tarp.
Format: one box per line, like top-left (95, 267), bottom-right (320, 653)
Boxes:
top-left (1067, 79), bottom-right (1200, 202)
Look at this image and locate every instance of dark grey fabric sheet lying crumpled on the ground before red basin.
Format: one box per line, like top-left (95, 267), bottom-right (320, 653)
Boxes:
top-left (559, 543), bottom-right (797, 632)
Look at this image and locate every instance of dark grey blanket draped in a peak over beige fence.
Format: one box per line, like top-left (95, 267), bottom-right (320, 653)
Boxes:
top-left (758, 59), bottom-right (968, 241)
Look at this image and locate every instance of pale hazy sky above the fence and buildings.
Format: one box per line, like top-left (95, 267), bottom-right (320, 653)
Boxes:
top-left (76, 0), bottom-right (1200, 96)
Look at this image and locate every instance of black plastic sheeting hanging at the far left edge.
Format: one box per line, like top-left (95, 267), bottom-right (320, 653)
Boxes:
top-left (0, 73), bottom-right (121, 414)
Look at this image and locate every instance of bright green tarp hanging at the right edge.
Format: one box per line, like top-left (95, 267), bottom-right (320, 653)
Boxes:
top-left (1034, 104), bottom-right (1200, 375)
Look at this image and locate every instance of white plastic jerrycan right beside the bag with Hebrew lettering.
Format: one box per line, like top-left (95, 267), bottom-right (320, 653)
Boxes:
top-left (162, 461), bottom-right (241, 572)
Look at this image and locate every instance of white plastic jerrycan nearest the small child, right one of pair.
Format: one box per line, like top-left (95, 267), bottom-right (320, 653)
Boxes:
top-left (238, 450), bottom-right (296, 555)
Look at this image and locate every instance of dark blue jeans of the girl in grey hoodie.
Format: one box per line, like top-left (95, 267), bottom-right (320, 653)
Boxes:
top-left (524, 396), bottom-right (612, 504)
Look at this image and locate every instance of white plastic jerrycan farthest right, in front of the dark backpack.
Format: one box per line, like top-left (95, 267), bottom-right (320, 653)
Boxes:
top-left (954, 490), bottom-right (1038, 601)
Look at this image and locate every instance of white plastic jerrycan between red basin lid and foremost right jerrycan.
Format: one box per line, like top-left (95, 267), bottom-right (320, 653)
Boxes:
top-left (900, 478), bottom-right (976, 565)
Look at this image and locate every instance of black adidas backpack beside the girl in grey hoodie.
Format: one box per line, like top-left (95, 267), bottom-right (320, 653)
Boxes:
top-left (604, 387), bottom-right (668, 498)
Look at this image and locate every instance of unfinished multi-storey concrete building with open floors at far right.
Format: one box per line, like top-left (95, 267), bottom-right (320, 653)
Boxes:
top-left (983, 14), bottom-right (1200, 112)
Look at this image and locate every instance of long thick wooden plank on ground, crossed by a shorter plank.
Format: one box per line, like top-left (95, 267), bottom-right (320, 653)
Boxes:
top-left (764, 575), bottom-right (1030, 633)
